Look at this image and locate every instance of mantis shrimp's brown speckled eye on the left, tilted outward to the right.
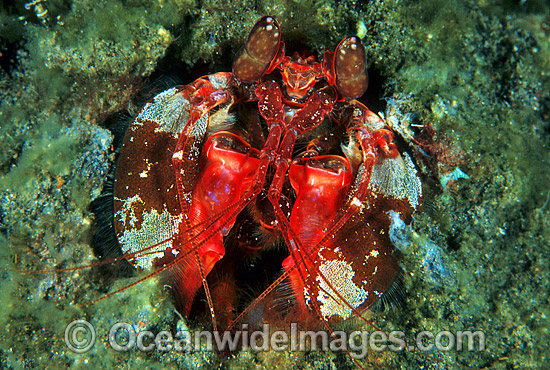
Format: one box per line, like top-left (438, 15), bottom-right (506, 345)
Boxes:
top-left (233, 16), bottom-right (281, 82)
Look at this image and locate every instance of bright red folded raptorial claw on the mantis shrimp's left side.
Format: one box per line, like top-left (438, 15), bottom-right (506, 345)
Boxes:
top-left (167, 131), bottom-right (258, 314)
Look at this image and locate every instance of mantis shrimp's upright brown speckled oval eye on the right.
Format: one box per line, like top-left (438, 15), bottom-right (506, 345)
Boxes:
top-left (333, 36), bottom-right (369, 98)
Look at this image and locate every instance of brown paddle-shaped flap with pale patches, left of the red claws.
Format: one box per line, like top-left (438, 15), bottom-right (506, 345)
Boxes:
top-left (114, 88), bottom-right (190, 268)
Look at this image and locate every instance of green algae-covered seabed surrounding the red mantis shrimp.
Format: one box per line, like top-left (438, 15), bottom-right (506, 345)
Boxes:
top-left (0, 0), bottom-right (550, 369)
